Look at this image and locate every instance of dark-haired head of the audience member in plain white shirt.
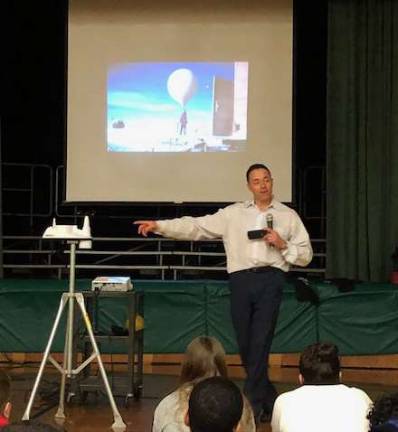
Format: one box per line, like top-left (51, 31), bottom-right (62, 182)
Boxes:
top-left (299, 343), bottom-right (340, 384)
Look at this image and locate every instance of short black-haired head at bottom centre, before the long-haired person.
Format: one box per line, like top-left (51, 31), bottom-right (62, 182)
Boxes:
top-left (188, 377), bottom-right (243, 432)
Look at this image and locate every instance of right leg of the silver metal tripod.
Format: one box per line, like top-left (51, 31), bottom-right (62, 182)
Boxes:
top-left (75, 293), bottom-right (126, 430)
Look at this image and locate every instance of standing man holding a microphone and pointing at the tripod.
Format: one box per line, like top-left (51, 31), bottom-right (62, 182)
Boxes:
top-left (135, 164), bottom-right (312, 421)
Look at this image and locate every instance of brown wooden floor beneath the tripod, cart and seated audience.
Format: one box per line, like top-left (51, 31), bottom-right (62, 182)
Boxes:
top-left (2, 366), bottom-right (398, 432)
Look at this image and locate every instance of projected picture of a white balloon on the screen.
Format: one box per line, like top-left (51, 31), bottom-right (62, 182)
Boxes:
top-left (107, 62), bottom-right (249, 152)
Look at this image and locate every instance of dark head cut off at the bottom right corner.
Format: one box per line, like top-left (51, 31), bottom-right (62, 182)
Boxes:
top-left (368, 393), bottom-right (398, 432)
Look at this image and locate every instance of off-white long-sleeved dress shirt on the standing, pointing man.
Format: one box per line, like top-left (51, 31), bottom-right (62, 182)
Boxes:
top-left (157, 200), bottom-right (312, 273)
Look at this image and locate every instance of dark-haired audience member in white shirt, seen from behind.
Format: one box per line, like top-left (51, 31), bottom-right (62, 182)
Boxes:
top-left (271, 343), bottom-right (372, 432)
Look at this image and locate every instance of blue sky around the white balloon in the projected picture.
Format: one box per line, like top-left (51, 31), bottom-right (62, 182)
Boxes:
top-left (108, 62), bottom-right (234, 121)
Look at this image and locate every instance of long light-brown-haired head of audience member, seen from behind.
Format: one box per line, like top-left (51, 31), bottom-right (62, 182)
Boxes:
top-left (180, 336), bottom-right (227, 384)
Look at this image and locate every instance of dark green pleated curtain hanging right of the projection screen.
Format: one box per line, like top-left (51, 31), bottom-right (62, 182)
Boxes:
top-left (327, 0), bottom-right (398, 281)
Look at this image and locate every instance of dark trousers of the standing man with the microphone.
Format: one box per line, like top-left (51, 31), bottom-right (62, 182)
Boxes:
top-left (229, 267), bottom-right (285, 418)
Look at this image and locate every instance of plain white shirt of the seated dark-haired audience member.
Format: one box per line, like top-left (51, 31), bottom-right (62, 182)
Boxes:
top-left (271, 384), bottom-right (372, 432)
